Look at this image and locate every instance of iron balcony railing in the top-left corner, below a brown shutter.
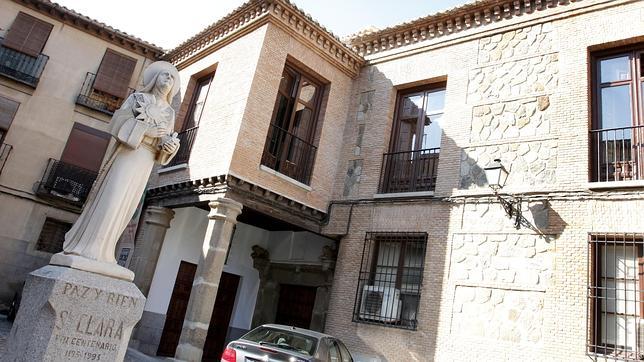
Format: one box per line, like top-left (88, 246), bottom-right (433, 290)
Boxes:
top-left (0, 38), bottom-right (49, 88)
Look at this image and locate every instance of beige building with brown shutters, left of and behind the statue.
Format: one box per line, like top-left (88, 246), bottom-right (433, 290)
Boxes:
top-left (0, 1), bottom-right (163, 302)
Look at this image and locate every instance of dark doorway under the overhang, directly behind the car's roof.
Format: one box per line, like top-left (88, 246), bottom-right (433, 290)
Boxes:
top-left (275, 284), bottom-right (317, 328)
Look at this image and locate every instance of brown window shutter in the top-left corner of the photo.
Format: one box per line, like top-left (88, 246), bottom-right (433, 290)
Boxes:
top-left (3, 12), bottom-right (54, 57)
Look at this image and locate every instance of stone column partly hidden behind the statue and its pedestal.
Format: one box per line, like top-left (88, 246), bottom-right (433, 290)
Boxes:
top-left (130, 206), bottom-right (174, 296)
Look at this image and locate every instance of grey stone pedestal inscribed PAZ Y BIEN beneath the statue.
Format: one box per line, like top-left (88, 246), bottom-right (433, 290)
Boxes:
top-left (2, 265), bottom-right (145, 361)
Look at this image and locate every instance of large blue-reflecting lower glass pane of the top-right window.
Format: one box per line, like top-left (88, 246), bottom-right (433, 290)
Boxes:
top-left (600, 85), bottom-right (632, 129)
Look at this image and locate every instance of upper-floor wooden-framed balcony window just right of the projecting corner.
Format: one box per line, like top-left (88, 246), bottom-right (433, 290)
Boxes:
top-left (378, 82), bottom-right (446, 193)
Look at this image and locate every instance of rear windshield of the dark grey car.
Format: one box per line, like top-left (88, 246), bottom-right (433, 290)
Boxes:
top-left (242, 327), bottom-right (318, 356)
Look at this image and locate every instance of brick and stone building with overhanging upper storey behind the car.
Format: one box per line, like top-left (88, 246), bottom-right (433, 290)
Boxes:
top-left (2, 0), bottom-right (644, 361)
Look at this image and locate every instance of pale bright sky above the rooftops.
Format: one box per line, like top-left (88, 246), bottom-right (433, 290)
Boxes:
top-left (54, 0), bottom-right (468, 49)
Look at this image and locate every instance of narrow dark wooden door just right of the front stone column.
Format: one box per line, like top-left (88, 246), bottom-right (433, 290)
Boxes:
top-left (201, 273), bottom-right (239, 361)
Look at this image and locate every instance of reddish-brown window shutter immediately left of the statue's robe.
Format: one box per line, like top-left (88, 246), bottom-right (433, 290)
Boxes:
top-left (60, 123), bottom-right (110, 172)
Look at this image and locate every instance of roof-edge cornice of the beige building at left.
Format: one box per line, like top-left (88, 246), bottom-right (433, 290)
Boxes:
top-left (13, 0), bottom-right (164, 59)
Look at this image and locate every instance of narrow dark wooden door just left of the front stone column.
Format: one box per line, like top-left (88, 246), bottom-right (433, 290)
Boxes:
top-left (157, 261), bottom-right (197, 357)
